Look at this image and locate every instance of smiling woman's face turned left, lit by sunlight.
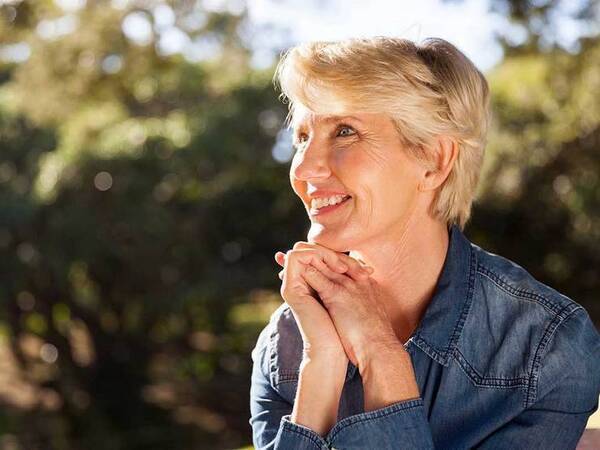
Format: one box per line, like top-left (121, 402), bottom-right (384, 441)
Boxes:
top-left (290, 109), bottom-right (425, 251)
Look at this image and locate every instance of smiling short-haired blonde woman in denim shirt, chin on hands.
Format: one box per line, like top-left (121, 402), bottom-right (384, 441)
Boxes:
top-left (249, 37), bottom-right (600, 449)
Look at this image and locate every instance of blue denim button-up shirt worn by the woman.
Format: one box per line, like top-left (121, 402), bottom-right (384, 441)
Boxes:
top-left (249, 225), bottom-right (600, 450)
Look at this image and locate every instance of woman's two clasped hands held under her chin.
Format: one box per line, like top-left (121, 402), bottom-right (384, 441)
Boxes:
top-left (275, 242), bottom-right (403, 369)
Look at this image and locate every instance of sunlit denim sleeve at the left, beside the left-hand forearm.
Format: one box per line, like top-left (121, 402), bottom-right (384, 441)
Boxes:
top-left (249, 325), bottom-right (330, 450)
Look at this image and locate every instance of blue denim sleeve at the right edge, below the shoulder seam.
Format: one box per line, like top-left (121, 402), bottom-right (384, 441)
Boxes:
top-left (477, 308), bottom-right (600, 450)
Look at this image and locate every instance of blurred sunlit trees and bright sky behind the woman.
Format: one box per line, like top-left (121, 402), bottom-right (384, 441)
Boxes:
top-left (0, 0), bottom-right (600, 450)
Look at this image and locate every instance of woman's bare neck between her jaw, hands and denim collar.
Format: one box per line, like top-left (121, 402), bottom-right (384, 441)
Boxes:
top-left (350, 217), bottom-right (449, 343)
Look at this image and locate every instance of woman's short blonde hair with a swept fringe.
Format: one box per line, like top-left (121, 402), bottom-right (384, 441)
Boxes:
top-left (273, 36), bottom-right (490, 229)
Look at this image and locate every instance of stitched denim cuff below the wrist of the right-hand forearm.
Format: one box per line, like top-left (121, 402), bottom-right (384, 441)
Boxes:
top-left (326, 398), bottom-right (434, 450)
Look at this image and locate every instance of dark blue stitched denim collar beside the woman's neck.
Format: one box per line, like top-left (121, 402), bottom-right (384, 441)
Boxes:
top-left (346, 224), bottom-right (477, 379)
